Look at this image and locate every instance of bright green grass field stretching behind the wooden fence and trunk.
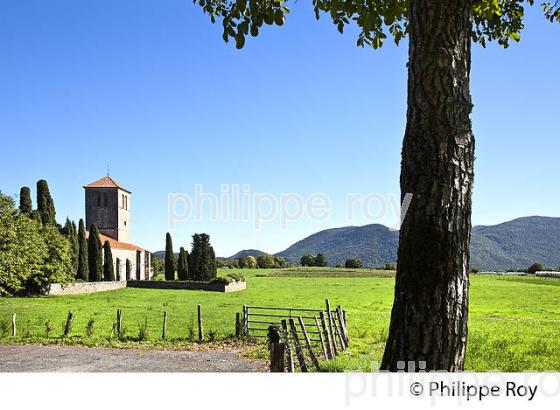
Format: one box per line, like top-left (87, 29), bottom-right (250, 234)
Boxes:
top-left (0, 269), bottom-right (560, 372)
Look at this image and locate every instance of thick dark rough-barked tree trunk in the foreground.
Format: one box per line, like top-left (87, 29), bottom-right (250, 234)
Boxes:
top-left (381, 0), bottom-right (474, 371)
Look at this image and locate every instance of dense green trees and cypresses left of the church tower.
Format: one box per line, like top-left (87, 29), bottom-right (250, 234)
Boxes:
top-left (0, 179), bottom-right (121, 296)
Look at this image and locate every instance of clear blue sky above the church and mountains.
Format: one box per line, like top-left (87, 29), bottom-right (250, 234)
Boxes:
top-left (0, 0), bottom-right (560, 256)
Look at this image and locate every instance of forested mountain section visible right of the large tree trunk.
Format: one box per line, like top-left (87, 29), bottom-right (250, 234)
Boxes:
top-left (471, 216), bottom-right (560, 270)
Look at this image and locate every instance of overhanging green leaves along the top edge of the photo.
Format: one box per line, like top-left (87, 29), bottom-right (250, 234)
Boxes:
top-left (193, 0), bottom-right (560, 48)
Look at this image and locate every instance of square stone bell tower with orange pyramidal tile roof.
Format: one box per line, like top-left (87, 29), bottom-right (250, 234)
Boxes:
top-left (84, 175), bottom-right (132, 243)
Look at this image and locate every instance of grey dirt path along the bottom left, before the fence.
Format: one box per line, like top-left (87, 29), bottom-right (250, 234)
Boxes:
top-left (0, 345), bottom-right (266, 373)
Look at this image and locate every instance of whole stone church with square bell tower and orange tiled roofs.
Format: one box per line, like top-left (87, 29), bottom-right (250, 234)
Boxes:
top-left (84, 175), bottom-right (153, 281)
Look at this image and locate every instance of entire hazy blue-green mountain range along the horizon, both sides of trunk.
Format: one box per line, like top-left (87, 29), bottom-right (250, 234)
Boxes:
top-left (223, 216), bottom-right (560, 271)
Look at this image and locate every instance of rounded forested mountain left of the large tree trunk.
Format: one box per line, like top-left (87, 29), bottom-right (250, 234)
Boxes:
top-left (278, 224), bottom-right (399, 266)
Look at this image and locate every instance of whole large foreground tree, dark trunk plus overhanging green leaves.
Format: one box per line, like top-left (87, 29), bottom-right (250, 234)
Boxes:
top-left (195, 0), bottom-right (560, 371)
